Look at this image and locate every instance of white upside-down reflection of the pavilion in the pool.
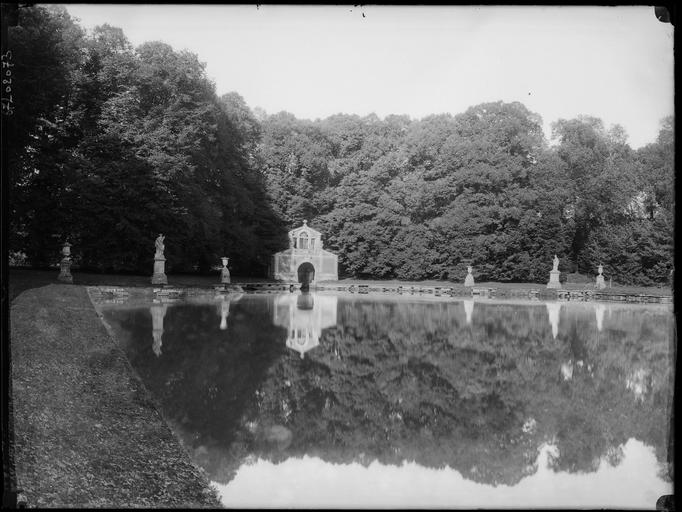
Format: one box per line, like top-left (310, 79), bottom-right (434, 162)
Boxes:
top-left (273, 293), bottom-right (338, 358)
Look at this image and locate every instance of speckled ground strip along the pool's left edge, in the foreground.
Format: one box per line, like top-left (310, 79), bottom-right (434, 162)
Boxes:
top-left (10, 284), bottom-right (220, 508)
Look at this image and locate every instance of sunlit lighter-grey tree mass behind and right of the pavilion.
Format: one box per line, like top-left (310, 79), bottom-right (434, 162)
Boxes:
top-left (260, 102), bottom-right (674, 285)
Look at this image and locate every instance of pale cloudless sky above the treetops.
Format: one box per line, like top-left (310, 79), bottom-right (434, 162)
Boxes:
top-left (61, 4), bottom-right (674, 148)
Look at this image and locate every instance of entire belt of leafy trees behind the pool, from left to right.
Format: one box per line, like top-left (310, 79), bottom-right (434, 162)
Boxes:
top-left (5, 6), bottom-right (675, 285)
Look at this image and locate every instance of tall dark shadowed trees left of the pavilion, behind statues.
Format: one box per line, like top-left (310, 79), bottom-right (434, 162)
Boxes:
top-left (11, 7), bottom-right (286, 274)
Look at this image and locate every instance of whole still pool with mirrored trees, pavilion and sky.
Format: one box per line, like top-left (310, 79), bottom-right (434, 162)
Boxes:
top-left (98, 292), bottom-right (674, 509)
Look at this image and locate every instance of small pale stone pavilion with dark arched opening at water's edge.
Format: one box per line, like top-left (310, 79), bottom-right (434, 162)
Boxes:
top-left (270, 220), bottom-right (339, 283)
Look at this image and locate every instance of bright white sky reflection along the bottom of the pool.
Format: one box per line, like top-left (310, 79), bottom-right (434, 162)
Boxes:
top-left (214, 439), bottom-right (672, 509)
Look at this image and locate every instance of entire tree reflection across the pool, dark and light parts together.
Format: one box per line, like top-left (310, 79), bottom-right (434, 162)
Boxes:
top-left (101, 301), bottom-right (669, 484)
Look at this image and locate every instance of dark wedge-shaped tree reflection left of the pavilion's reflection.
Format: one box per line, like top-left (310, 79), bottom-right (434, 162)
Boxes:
top-left (105, 299), bottom-right (286, 482)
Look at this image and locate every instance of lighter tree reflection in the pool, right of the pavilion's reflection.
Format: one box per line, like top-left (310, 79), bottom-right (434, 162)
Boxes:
top-left (236, 302), bottom-right (667, 483)
